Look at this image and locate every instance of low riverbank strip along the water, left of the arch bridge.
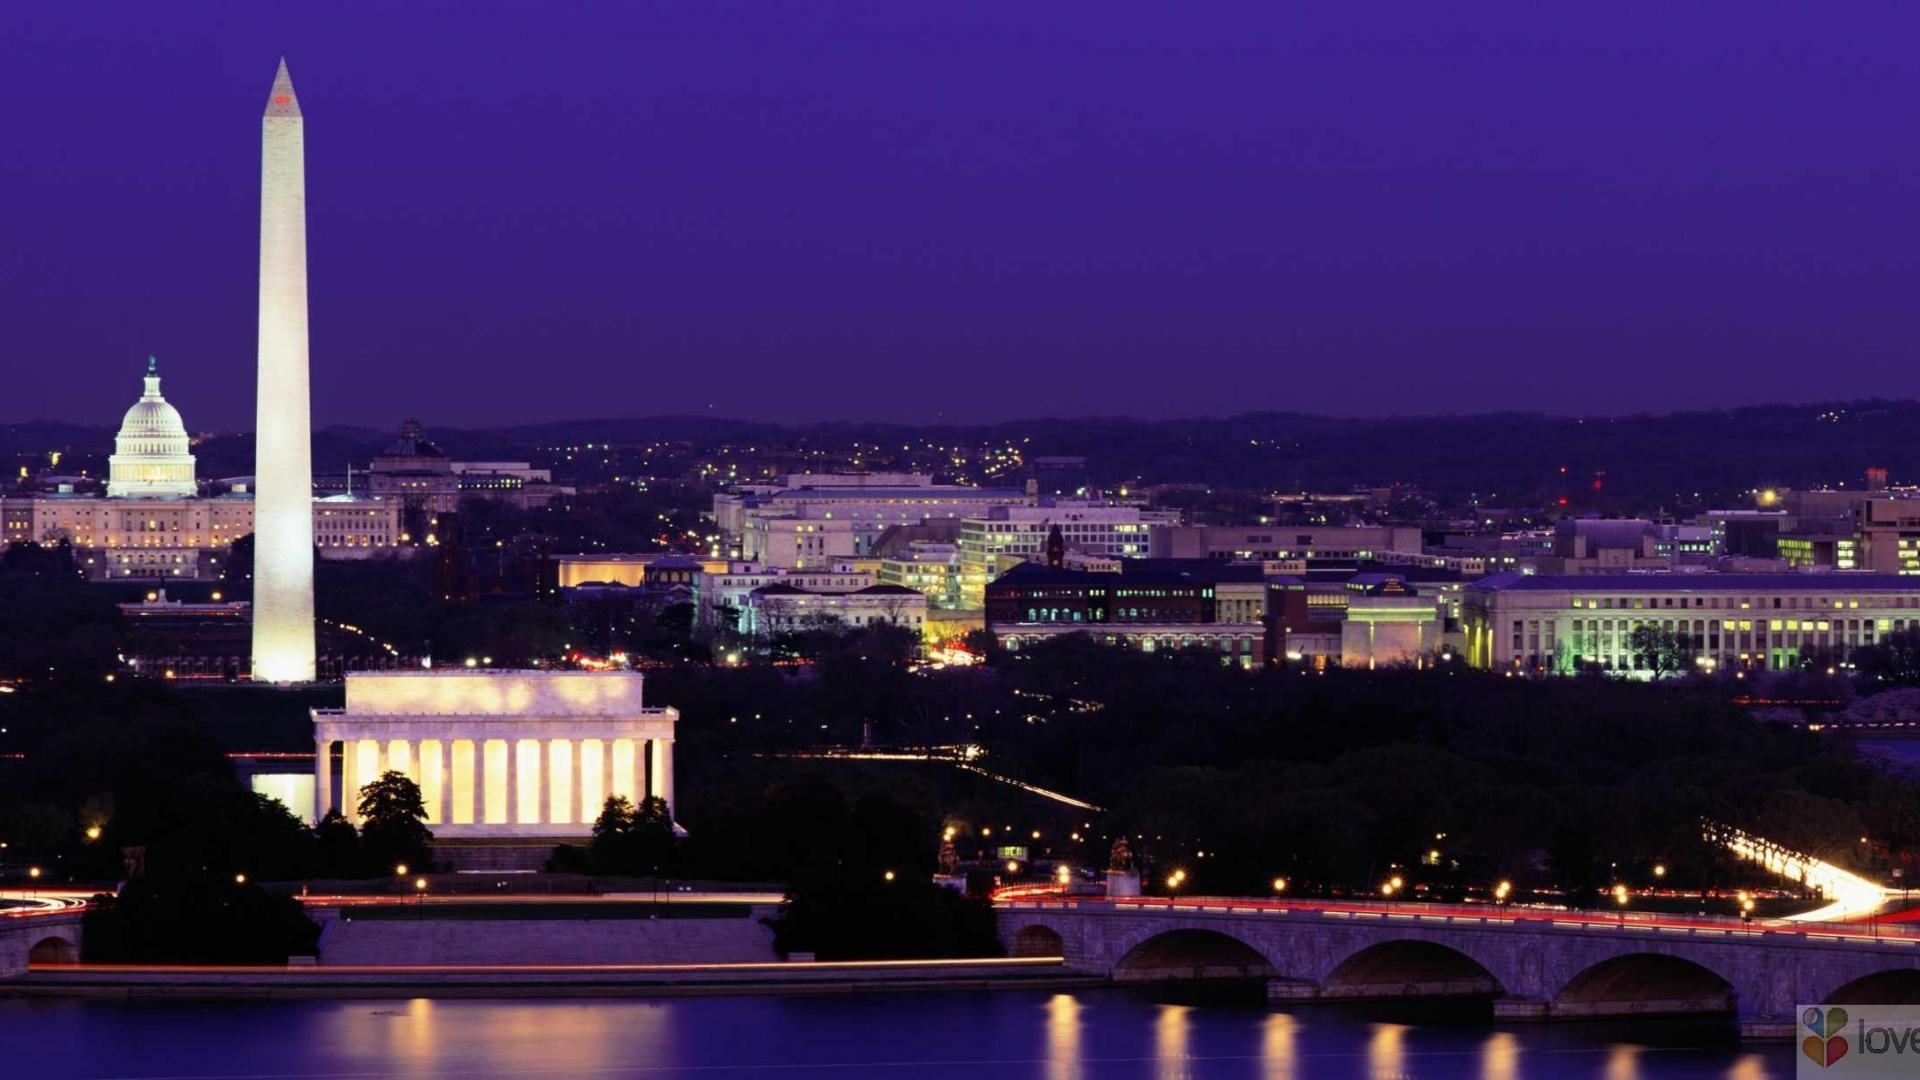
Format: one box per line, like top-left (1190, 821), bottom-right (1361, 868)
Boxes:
top-left (0, 957), bottom-right (1106, 999)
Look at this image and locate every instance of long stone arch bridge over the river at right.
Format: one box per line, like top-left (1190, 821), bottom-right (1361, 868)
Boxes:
top-left (995, 899), bottom-right (1920, 1036)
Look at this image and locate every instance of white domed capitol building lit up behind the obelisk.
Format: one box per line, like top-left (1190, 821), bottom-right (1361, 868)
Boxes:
top-left (0, 357), bottom-right (401, 582)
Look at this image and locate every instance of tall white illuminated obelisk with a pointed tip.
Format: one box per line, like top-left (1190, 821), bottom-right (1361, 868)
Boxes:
top-left (253, 60), bottom-right (315, 682)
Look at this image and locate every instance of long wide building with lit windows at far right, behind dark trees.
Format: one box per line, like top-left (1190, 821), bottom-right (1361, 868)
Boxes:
top-left (1461, 571), bottom-right (1920, 675)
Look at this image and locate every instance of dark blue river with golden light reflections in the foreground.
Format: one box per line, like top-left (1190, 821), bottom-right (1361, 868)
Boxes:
top-left (0, 988), bottom-right (1795, 1080)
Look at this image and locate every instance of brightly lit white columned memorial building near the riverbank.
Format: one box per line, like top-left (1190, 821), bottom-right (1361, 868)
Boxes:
top-left (313, 671), bottom-right (680, 838)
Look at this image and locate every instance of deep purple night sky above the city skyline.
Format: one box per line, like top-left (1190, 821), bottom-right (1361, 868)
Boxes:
top-left (0, 0), bottom-right (1920, 429)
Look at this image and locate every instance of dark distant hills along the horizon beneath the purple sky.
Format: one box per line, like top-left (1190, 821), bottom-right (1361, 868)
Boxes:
top-left (0, 400), bottom-right (1920, 509)
